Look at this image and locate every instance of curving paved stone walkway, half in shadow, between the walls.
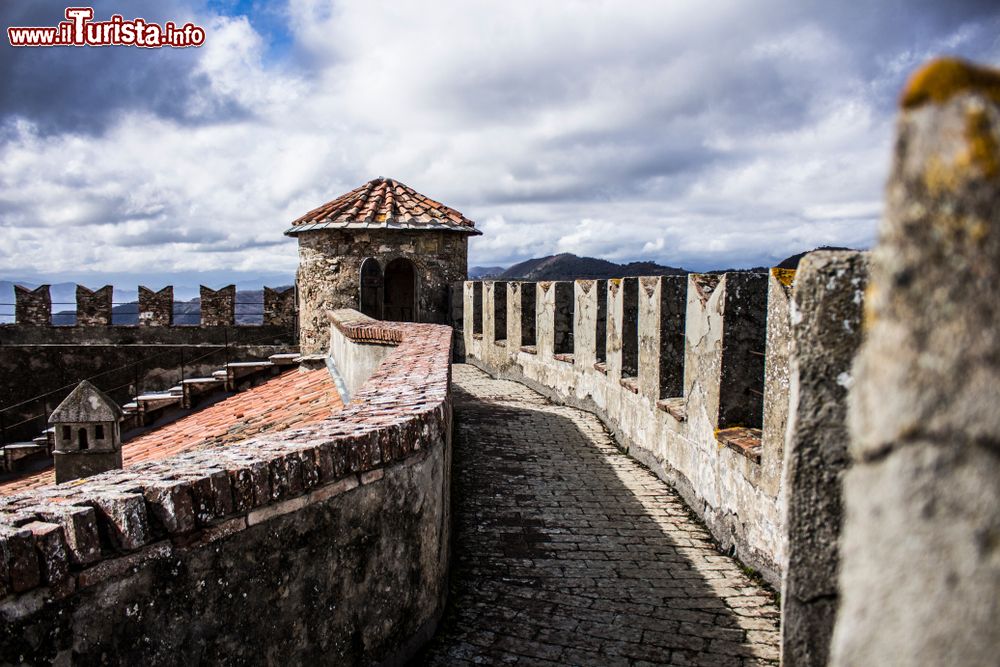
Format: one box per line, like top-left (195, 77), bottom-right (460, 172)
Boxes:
top-left (415, 365), bottom-right (778, 667)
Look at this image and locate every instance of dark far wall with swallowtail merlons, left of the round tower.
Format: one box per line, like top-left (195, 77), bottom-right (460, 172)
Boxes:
top-left (0, 285), bottom-right (297, 443)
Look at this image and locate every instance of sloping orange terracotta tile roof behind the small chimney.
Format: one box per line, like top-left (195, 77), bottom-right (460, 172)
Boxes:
top-left (0, 368), bottom-right (344, 496)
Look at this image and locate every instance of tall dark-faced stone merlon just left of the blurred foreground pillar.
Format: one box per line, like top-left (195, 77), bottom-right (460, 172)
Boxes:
top-left (780, 252), bottom-right (868, 667)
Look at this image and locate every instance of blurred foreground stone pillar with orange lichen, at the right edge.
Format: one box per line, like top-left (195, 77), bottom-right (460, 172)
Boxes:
top-left (832, 60), bottom-right (1000, 666)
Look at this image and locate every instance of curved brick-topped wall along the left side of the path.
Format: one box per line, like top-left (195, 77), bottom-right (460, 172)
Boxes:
top-left (0, 310), bottom-right (451, 664)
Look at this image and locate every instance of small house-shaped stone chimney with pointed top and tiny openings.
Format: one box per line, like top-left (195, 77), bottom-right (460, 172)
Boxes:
top-left (49, 380), bottom-right (122, 484)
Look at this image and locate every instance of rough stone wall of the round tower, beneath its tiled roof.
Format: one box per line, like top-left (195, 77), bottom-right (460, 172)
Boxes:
top-left (297, 229), bottom-right (468, 354)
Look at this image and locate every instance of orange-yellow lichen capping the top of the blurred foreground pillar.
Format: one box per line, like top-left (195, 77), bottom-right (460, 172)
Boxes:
top-left (900, 58), bottom-right (1000, 109)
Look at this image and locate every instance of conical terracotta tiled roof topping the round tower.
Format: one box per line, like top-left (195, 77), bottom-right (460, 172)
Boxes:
top-left (285, 178), bottom-right (482, 236)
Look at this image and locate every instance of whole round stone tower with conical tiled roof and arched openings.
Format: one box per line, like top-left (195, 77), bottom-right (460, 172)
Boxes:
top-left (285, 178), bottom-right (481, 354)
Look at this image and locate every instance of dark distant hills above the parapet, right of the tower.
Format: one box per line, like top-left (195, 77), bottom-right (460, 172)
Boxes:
top-left (469, 246), bottom-right (847, 281)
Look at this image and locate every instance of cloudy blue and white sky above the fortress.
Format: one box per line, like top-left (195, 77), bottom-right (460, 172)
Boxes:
top-left (0, 0), bottom-right (1000, 285)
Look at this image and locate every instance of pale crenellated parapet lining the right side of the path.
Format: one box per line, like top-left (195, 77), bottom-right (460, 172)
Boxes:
top-left (464, 260), bottom-right (864, 584)
